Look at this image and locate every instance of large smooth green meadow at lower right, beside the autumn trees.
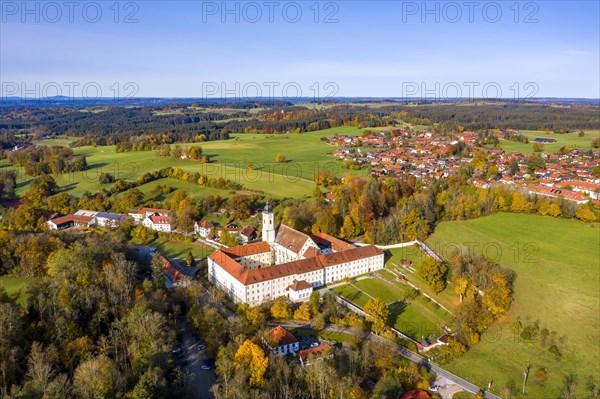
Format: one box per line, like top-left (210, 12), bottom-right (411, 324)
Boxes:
top-left (427, 214), bottom-right (600, 398)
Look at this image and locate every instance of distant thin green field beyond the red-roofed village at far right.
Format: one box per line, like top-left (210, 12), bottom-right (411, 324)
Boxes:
top-left (500, 130), bottom-right (600, 154)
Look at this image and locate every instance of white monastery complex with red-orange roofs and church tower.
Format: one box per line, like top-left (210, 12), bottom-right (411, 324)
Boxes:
top-left (208, 203), bottom-right (384, 306)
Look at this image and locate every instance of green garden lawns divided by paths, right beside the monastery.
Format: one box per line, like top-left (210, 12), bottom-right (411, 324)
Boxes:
top-left (333, 270), bottom-right (450, 340)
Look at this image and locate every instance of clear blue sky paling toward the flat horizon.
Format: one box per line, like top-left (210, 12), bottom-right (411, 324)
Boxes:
top-left (0, 0), bottom-right (600, 98)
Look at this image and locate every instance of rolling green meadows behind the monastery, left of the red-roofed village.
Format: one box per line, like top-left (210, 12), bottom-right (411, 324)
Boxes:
top-left (9, 127), bottom-right (380, 199)
